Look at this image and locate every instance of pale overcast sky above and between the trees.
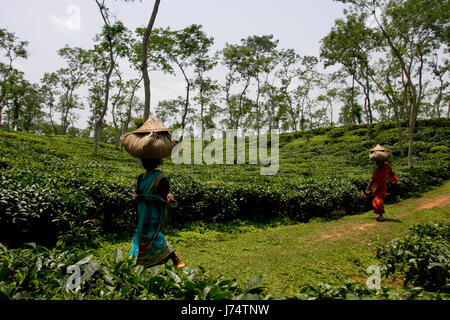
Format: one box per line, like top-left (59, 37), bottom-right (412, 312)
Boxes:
top-left (0, 0), bottom-right (344, 127)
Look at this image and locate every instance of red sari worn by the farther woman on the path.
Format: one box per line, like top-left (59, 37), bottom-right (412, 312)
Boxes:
top-left (372, 163), bottom-right (398, 214)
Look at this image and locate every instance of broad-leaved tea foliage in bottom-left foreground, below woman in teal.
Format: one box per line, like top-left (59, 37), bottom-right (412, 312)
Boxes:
top-left (0, 243), bottom-right (264, 300)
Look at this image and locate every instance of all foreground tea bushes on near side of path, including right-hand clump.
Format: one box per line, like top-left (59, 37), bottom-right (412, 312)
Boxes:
top-left (0, 224), bottom-right (450, 300)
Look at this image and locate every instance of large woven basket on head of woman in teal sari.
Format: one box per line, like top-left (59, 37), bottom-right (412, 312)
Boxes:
top-left (122, 118), bottom-right (178, 159)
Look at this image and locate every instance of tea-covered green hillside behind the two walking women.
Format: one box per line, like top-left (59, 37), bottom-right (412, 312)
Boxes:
top-left (0, 119), bottom-right (450, 245)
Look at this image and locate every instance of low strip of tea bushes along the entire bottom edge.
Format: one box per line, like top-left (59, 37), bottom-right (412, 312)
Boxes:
top-left (0, 242), bottom-right (450, 300)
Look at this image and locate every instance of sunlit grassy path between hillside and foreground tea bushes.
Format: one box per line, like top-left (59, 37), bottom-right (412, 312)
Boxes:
top-left (98, 182), bottom-right (450, 294)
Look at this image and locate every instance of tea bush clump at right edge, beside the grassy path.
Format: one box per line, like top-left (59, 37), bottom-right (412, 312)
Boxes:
top-left (377, 224), bottom-right (450, 293)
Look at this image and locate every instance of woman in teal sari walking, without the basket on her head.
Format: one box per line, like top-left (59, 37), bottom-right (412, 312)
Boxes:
top-left (130, 159), bottom-right (185, 268)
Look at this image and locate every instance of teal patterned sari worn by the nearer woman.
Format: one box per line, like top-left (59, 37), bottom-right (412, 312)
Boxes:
top-left (130, 170), bottom-right (174, 268)
